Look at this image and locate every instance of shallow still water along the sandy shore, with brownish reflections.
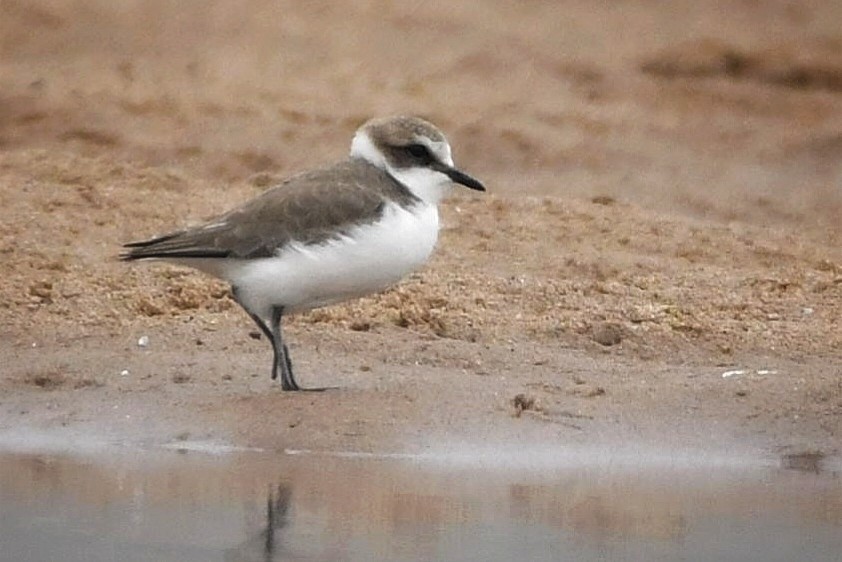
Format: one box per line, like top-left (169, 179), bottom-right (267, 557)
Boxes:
top-left (0, 446), bottom-right (842, 562)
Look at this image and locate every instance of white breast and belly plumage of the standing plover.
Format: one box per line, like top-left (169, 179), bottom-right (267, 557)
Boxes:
top-left (217, 204), bottom-right (439, 317)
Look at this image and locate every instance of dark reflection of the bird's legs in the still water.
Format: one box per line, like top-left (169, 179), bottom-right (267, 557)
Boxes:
top-left (225, 484), bottom-right (295, 562)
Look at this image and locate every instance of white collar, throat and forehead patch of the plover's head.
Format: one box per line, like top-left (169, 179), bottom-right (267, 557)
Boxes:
top-left (351, 130), bottom-right (453, 205)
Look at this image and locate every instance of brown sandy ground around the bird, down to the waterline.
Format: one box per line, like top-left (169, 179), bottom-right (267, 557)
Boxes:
top-left (0, 0), bottom-right (842, 454)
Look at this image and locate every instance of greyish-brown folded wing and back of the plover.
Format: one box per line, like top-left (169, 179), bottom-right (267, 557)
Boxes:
top-left (120, 160), bottom-right (415, 260)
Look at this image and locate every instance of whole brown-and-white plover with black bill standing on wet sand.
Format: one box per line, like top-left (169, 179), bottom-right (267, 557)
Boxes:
top-left (120, 116), bottom-right (485, 390)
